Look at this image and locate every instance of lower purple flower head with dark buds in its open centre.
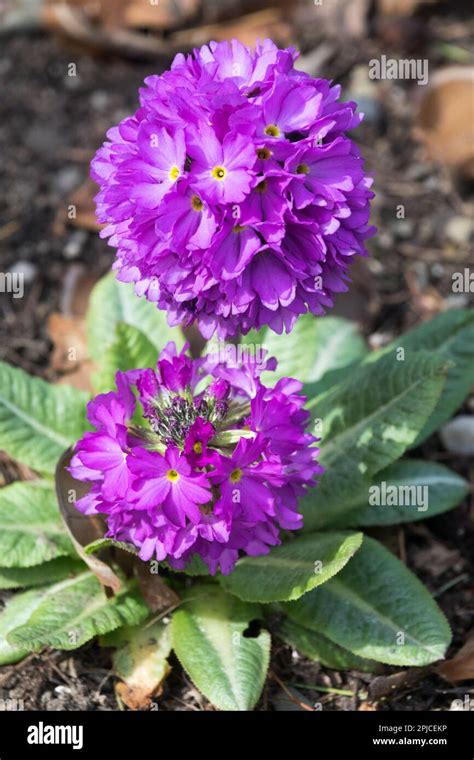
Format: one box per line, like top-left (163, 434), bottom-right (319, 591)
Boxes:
top-left (70, 343), bottom-right (322, 573)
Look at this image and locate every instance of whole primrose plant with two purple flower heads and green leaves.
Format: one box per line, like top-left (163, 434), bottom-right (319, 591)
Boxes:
top-left (0, 41), bottom-right (474, 710)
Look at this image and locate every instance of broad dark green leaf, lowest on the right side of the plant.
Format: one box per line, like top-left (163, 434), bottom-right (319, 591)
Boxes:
top-left (284, 537), bottom-right (451, 665)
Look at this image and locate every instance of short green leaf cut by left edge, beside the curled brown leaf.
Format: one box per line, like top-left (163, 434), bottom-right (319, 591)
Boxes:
top-left (0, 482), bottom-right (77, 567)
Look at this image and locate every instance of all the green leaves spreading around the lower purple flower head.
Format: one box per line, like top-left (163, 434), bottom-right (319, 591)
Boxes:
top-left (0, 308), bottom-right (474, 710)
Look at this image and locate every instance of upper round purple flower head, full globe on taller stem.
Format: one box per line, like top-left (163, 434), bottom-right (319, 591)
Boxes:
top-left (92, 40), bottom-right (374, 338)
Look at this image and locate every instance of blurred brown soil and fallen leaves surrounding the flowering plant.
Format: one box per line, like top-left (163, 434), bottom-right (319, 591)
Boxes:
top-left (0, 0), bottom-right (474, 709)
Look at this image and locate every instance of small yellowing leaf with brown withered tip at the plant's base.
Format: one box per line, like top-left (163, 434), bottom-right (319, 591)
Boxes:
top-left (106, 621), bottom-right (171, 704)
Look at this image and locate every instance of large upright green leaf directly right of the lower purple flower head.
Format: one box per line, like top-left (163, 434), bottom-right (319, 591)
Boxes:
top-left (301, 352), bottom-right (446, 531)
